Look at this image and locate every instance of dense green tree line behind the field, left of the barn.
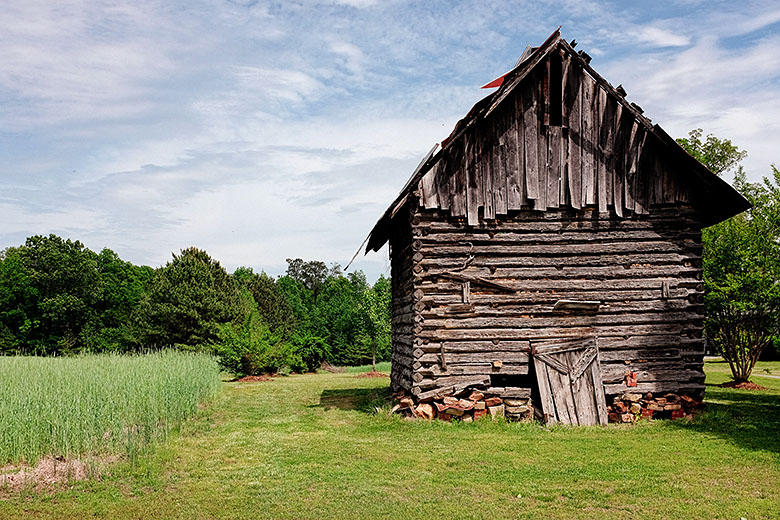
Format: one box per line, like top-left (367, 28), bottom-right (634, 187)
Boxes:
top-left (0, 242), bottom-right (390, 374)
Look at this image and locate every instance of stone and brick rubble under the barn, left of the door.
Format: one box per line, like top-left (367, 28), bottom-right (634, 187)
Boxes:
top-left (392, 390), bottom-right (534, 422)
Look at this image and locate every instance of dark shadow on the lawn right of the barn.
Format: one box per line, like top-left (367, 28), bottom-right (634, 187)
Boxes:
top-left (671, 385), bottom-right (780, 453)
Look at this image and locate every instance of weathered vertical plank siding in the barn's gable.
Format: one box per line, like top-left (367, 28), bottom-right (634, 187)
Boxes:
top-left (417, 55), bottom-right (690, 225)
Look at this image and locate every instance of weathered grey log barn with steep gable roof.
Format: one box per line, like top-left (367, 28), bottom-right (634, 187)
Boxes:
top-left (366, 31), bottom-right (749, 424)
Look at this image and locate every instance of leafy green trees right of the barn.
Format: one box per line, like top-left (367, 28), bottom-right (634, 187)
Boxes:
top-left (677, 129), bottom-right (780, 382)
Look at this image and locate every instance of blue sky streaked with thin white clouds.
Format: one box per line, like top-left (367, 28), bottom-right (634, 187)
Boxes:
top-left (0, 0), bottom-right (780, 279)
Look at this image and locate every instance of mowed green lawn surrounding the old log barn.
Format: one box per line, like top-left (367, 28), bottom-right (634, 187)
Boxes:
top-left (0, 363), bottom-right (780, 520)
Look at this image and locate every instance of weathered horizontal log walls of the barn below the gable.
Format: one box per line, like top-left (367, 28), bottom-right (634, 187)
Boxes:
top-left (402, 205), bottom-right (704, 395)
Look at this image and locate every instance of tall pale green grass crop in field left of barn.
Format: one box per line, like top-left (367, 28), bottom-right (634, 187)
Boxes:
top-left (0, 351), bottom-right (221, 464)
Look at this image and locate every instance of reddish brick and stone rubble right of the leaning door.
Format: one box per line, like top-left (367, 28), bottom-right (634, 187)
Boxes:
top-left (607, 392), bottom-right (703, 423)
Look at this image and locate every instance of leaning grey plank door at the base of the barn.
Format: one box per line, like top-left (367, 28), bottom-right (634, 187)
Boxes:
top-left (531, 338), bottom-right (607, 426)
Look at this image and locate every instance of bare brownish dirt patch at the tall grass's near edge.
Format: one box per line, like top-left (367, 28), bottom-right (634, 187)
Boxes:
top-left (0, 456), bottom-right (119, 498)
